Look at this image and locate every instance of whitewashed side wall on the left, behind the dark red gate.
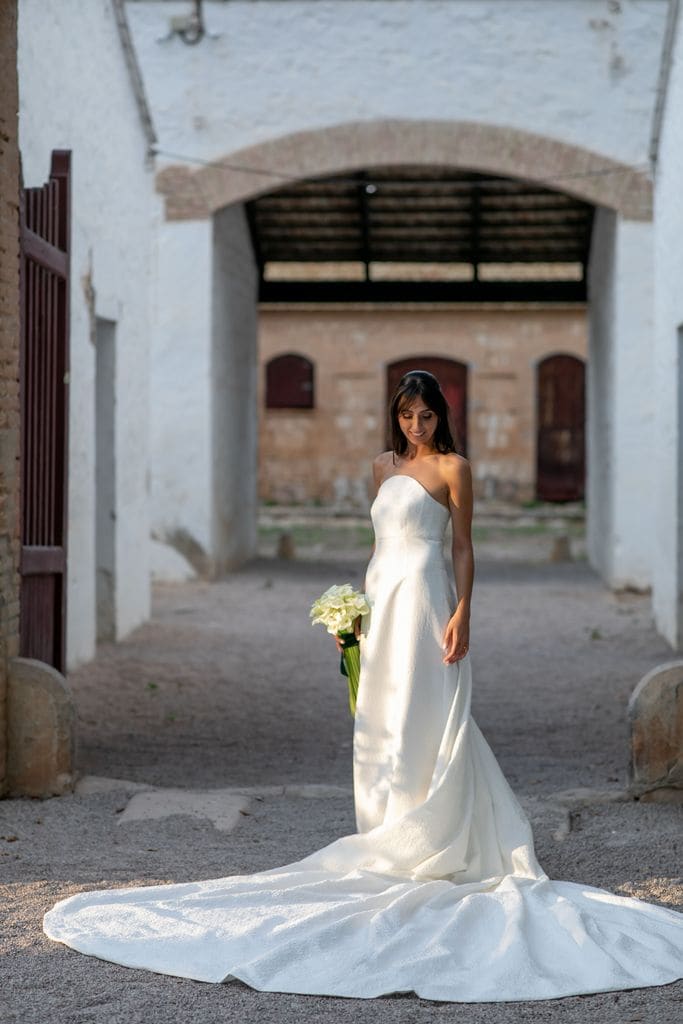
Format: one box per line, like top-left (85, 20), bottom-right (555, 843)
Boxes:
top-left (18, 0), bottom-right (161, 668)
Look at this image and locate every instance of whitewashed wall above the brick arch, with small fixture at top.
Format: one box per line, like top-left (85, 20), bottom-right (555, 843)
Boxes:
top-left (127, 0), bottom-right (667, 172)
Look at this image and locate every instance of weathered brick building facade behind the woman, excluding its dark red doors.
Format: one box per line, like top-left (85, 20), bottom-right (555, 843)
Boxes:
top-left (259, 304), bottom-right (587, 508)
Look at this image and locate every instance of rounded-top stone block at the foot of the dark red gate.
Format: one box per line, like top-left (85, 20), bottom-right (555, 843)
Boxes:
top-left (7, 657), bottom-right (76, 797)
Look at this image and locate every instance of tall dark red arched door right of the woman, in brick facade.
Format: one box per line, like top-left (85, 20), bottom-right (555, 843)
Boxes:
top-left (537, 355), bottom-right (586, 502)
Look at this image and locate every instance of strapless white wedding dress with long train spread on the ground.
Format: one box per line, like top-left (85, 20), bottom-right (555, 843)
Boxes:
top-left (44, 474), bottom-right (683, 1001)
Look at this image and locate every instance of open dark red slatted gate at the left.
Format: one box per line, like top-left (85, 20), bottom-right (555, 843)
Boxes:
top-left (19, 150), bottom-right (71, 672)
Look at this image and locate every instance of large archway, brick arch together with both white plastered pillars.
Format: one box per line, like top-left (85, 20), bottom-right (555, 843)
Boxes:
top-left (150, 119), bottom-right (651, 614)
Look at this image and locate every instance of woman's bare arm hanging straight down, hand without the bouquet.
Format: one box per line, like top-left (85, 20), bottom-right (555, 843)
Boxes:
top-left (443, 458), bottom-right (474, 665)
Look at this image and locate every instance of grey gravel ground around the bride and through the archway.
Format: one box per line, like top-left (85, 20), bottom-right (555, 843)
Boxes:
top-left (0, 552), bottom-right (683, 1024)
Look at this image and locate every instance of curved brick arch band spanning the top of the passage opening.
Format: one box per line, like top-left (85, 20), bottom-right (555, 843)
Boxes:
top-left (157, 120), bottom-right (652, 220)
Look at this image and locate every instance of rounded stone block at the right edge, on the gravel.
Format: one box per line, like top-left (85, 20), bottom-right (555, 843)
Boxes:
top-left (629, 660), bottom-right (683, 800)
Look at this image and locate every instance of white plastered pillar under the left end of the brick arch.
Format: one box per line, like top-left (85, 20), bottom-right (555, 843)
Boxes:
top-left (151, 206), bottom-right (258, 580)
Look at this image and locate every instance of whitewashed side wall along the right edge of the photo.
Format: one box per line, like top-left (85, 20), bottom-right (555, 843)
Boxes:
top-left (643, 14), bottom-right (683, 647)
